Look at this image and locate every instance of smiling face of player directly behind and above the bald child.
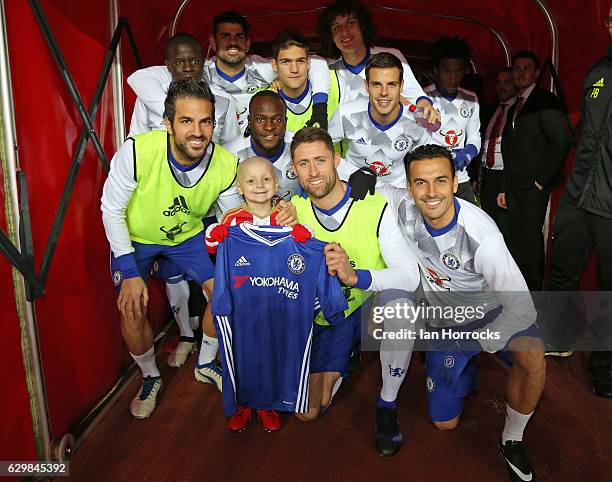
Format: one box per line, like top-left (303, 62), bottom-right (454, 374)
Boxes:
top-left (249, 96), bottom-right (287, 157)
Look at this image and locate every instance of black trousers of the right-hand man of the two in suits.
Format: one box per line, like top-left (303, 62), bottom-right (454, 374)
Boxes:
top-left (506, 186), bottom-right (550, 291)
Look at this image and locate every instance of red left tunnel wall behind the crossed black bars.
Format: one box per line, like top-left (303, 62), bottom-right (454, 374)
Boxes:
top-left (0, 0), bottom-right (167, 460)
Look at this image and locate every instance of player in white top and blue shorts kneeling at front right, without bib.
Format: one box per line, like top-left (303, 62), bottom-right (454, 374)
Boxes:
top-left (383, 145), bottom-right (546, 481)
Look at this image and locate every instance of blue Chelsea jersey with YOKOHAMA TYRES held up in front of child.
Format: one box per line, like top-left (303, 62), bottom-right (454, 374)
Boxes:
top-left (212, 223), bottom-right (347, 416)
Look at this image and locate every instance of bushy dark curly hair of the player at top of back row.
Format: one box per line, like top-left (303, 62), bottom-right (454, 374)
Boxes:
top-left (317, 0), bottom-right (376, 59)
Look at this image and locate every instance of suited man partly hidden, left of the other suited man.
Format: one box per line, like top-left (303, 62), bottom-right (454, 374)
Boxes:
top-left (480, 67), bottom-right (516, 240)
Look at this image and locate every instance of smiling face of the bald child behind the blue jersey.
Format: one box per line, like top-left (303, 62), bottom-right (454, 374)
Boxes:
top-left (236, 157), bottom-right (278, 204)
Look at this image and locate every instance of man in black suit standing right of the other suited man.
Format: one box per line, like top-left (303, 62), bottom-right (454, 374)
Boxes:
top-left (497, 51), bottom-right (570, 290)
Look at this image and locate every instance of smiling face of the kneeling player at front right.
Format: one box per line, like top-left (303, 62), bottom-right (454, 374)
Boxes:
top-left (408, 157), bottom-right (458, 229)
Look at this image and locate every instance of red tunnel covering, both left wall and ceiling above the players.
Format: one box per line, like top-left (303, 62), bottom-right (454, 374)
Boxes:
top-left (0, 0), bottom-right (609, 459)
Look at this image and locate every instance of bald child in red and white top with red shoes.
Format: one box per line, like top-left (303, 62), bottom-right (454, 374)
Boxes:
top-left (206, 157), bottom-right (292, 432)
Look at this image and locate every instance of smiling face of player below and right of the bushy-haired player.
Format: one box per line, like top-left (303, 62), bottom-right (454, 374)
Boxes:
top-left (365, 67), bottom-right (404, 124)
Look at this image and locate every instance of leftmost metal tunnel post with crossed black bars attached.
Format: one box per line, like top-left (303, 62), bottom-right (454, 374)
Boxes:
top-left (0, 0), bottom-right (141, 460)
